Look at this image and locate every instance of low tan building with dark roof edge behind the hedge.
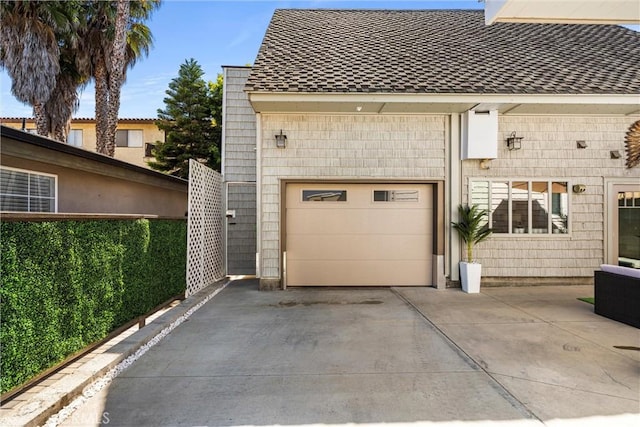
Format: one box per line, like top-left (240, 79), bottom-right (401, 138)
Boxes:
top-left (0, 126), bottom-right (188, 218)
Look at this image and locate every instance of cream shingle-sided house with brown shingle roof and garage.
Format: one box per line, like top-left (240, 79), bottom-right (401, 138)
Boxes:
top-left (223, 10), bottom-right (640, 288)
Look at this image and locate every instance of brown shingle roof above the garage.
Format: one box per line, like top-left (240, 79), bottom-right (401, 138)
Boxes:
top-left (246, 9), bottom-right (640, 94)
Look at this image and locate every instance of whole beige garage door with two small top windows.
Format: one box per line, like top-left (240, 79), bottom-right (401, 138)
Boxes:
top-left (285, 183), bottom-right (433, 286)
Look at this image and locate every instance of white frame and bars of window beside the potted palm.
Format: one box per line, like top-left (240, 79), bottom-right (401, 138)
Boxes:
top-left (468, 178), bottom-right (572, 238)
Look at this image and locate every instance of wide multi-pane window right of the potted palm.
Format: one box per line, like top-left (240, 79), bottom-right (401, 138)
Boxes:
top-left (470, 180), bottom-right (569, 235)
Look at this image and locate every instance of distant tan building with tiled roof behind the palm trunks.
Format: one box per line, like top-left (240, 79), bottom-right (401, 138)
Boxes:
top-left (0, 117), bottom-right (164, 171)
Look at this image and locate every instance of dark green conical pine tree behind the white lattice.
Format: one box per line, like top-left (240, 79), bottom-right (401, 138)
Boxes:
top-left (149, 58), bottom-right (220, 178)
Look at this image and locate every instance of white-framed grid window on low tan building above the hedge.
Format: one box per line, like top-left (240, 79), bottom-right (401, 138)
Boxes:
top-left (0, 167), bottom-right (57, 212)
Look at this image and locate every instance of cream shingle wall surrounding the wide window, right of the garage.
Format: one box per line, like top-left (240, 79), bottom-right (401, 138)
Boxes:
top-left (461, 116), bottom-right (640, 277)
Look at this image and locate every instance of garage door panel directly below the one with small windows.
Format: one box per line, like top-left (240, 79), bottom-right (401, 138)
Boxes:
top-left (287, 209), bottom-right (432, 235)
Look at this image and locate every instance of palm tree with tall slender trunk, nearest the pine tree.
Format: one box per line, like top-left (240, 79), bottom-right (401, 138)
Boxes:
top-left (76, 0), bottom-right (160, 156)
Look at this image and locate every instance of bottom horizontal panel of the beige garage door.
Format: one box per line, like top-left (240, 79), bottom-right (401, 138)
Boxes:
top-left (287, 261), bottom-right (431, 286)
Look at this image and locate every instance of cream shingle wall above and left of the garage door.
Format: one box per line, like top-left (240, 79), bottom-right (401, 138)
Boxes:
top-left (258, 114), bottom-right (448, 279)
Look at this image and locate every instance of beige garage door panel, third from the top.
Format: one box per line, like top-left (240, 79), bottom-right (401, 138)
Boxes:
top-left (287, 234), bottom-right (431, 263)
